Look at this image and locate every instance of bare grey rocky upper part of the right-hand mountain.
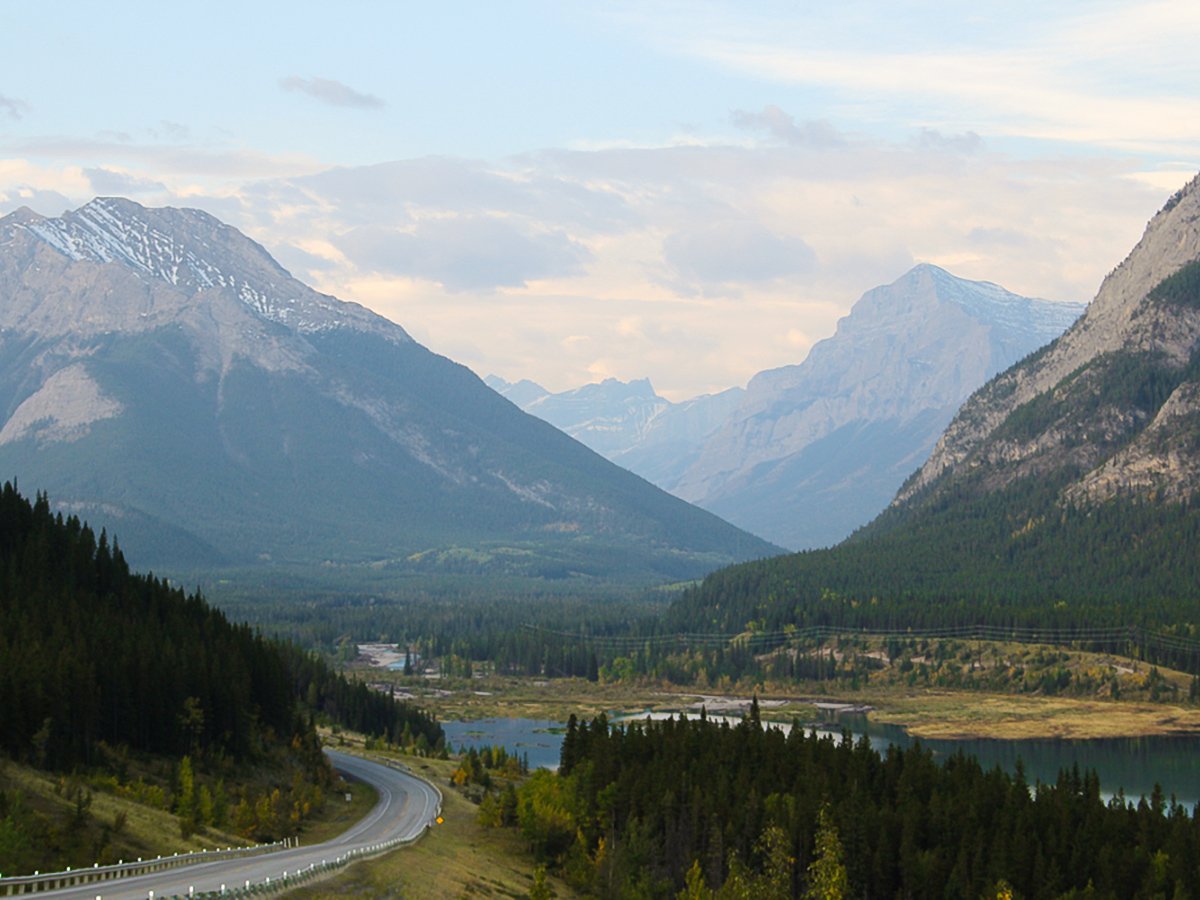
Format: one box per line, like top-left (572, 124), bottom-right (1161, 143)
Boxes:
top-left (895, 172), bottom-right (1200, 508)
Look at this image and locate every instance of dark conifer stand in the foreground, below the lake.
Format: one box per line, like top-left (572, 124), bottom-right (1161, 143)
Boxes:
top-left (508, 707), bottom-right (1200, 900)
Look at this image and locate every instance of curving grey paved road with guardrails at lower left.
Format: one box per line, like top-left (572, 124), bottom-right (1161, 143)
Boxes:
top-left (31, 751), bottom-right (440, 900)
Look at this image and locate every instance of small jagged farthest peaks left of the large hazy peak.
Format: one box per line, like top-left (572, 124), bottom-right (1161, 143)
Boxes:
top-left (484, 376), bottom-right (744, 491)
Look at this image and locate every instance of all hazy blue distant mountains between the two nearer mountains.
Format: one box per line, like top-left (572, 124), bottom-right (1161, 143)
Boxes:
top-left (487, 264), bottom-right (1084, 548)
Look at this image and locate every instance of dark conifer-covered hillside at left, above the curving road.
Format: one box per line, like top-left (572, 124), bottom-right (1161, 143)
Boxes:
top-left (0, 484), bottom-right (442, 770)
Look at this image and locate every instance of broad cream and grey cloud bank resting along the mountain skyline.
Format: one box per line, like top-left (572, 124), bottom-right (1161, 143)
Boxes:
top-left (11, 94), bottom-right (1161, 400)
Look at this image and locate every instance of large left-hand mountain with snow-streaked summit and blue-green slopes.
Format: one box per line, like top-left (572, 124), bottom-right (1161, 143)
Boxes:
top-left (0, 198), bottom-right (773, 577)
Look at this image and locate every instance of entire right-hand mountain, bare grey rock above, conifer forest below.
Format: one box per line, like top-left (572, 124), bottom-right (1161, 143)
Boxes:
top-left (671, 176), bottom-right (1200, 637)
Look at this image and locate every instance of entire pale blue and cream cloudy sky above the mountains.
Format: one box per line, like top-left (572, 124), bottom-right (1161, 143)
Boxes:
top-left (0, 0), bottom-right (1200, 401)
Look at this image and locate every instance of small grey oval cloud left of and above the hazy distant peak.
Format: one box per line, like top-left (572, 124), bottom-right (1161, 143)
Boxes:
top-left (662, 220), bottom-right (816, 284)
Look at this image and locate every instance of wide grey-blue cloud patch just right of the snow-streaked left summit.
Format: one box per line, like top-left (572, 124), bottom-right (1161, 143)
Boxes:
top-left (334, 216), bottom-right (590, 293)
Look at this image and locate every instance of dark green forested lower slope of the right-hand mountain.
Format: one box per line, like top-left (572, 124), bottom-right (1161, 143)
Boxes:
top-left (667, 487), bottom-right (1200, 637)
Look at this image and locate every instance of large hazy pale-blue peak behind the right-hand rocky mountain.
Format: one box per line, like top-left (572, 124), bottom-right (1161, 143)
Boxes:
top-left (672, 265), bottom-right (1082, 548)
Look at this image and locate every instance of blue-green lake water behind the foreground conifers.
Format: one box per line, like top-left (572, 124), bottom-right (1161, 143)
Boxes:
top-left (442, 713), bottom-right (1200, 808)
